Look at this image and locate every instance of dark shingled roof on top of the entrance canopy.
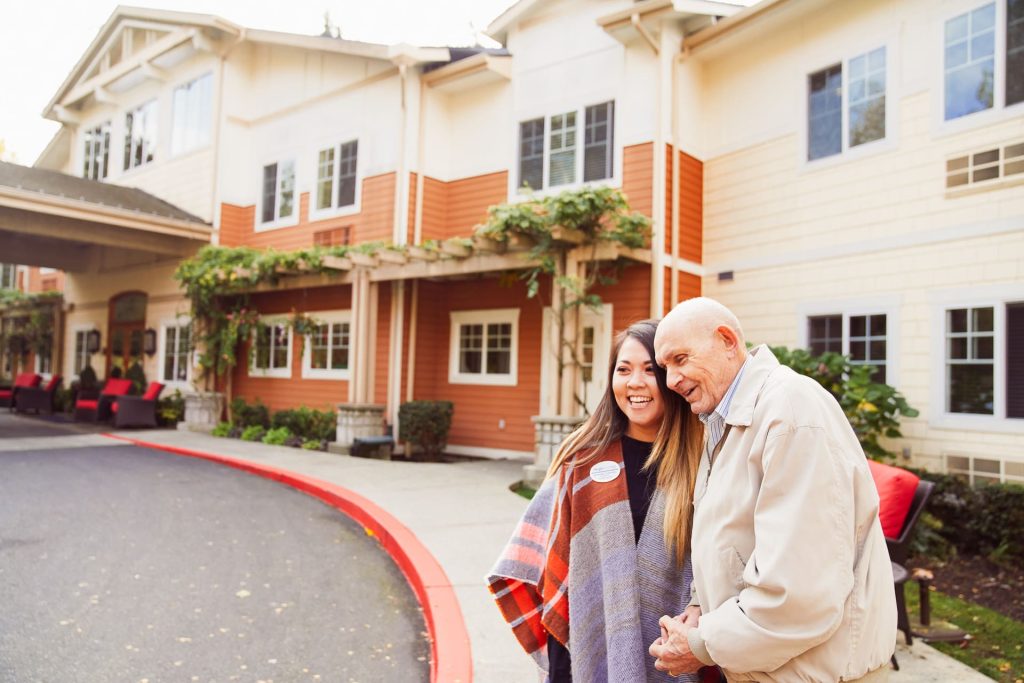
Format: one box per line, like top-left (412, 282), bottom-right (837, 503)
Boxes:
top-left (0, 162), bottom-right (209, 226)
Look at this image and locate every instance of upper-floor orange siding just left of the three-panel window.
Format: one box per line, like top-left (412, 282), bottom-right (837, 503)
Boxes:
top-left (423, 171), bottom-right (508, 241)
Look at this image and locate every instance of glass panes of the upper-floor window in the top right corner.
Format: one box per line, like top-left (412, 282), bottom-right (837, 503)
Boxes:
top-left (943, 0), bottom-right (1024, 121)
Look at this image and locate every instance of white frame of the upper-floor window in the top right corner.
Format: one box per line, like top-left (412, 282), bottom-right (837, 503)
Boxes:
top-left (932, 0), bottom-right (1024, 137)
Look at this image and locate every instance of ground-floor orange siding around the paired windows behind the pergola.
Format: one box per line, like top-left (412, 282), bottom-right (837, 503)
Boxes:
top-left (231, 285), bottom-right (352, 412)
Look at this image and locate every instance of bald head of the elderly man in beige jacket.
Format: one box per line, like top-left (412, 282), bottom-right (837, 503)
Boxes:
top-left (654, 297), bottom-right (746, 413)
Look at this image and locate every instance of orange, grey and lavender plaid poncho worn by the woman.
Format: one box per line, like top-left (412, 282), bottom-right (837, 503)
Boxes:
top-left (487, 442), bottom-right (697, 683)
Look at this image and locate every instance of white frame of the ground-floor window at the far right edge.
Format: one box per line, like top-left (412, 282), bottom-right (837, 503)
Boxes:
top-left (929, 284), bottom-right (1024, 434)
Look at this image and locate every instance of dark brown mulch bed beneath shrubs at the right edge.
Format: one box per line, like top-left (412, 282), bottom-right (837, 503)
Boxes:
top-left (907, 555), bottom-right (1024, 622)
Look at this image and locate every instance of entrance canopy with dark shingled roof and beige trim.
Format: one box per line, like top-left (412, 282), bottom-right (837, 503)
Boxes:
top-left (0, 162), bottom-right (212, 272)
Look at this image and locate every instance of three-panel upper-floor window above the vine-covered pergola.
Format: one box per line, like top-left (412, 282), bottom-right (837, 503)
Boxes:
top-left (517, 101), bottom-right (615, 189)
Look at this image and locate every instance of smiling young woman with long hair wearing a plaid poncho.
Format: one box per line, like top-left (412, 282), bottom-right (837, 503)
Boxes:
top-left (488, 321), bottom-right (702, 683)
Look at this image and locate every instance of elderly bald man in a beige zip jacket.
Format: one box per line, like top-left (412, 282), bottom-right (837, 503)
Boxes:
top-left (650, 298), bottom-right (896, 683)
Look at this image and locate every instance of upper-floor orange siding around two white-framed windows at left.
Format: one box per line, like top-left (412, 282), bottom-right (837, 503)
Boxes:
top-left (220, 172), bottom-right (395, 251)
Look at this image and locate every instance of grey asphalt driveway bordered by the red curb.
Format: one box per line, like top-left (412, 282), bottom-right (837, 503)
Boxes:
top-left (0, 438), bottom-right (430, 683)
